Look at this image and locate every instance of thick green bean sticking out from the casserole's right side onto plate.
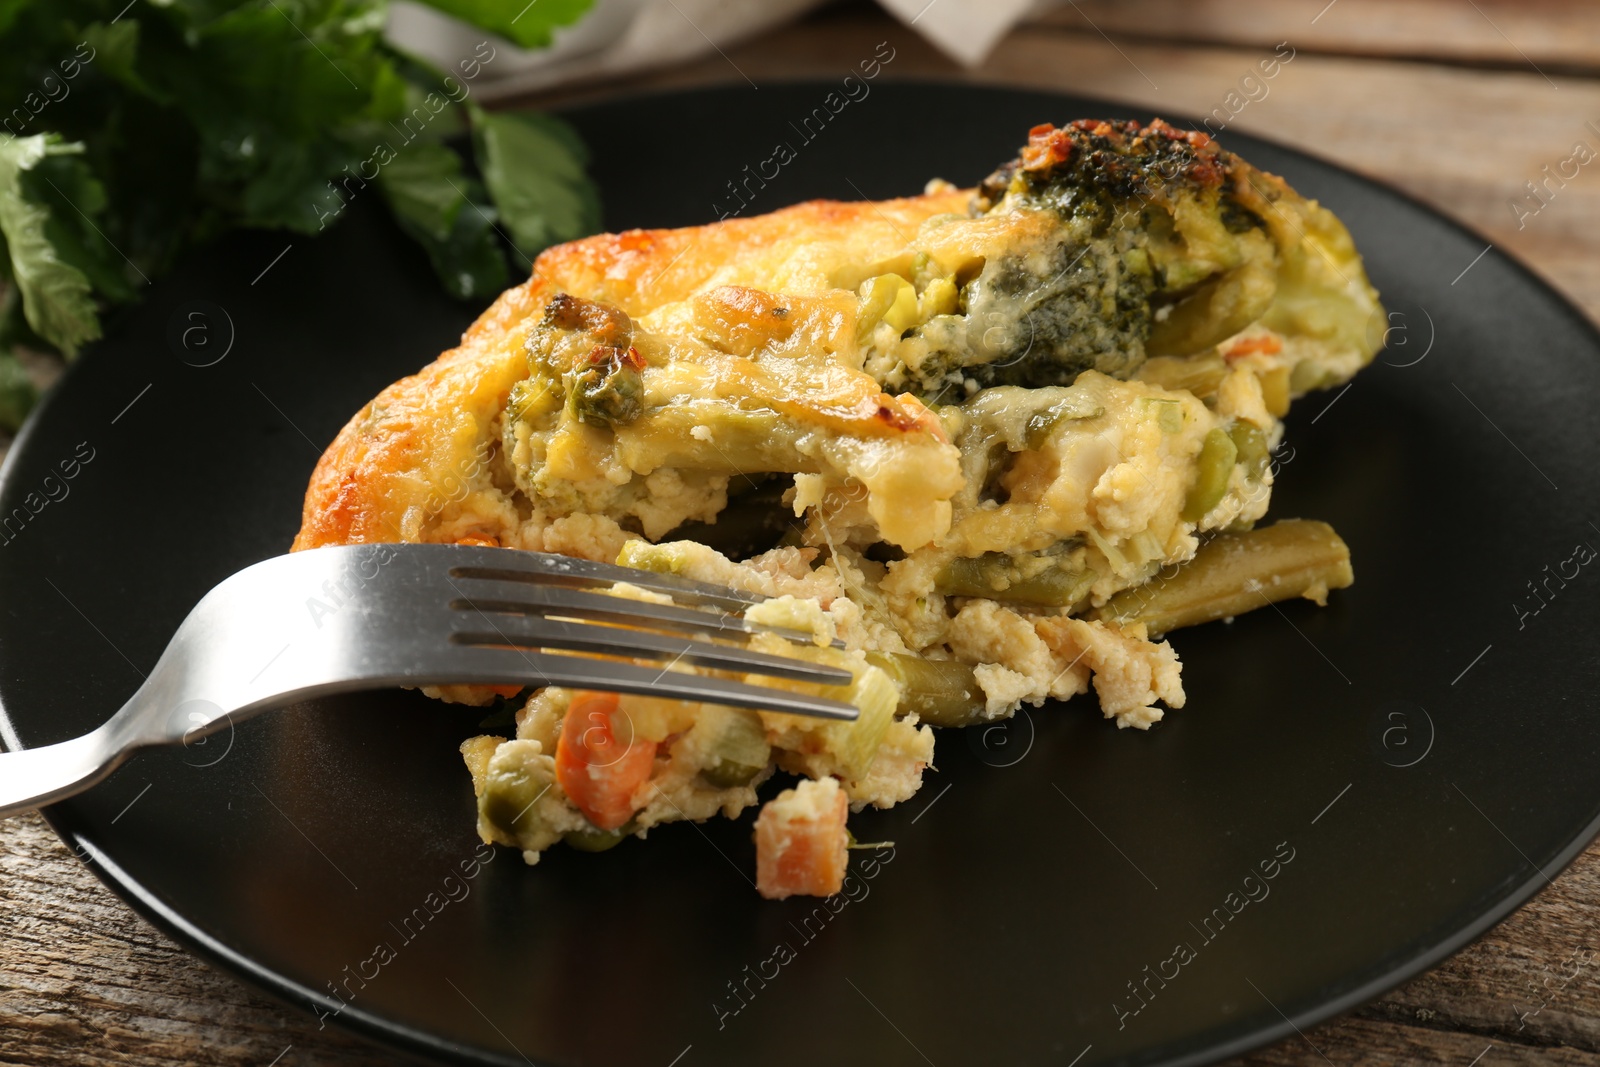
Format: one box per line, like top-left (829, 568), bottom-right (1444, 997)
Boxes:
top-left (1098, 518), bottom-right (1355, 633)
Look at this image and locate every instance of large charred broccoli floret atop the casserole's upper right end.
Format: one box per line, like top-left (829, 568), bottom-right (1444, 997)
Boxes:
top-left (906, 120), bottom-right (1374, 397)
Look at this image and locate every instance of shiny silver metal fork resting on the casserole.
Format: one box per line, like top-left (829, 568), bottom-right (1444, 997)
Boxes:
top-left (0, 544), bottom-right (856, 817)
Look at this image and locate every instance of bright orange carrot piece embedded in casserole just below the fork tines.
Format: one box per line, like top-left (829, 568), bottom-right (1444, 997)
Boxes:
top-left (555, 689), bottom-right (656, 830)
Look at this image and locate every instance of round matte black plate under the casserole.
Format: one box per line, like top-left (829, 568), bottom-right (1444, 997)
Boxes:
top-left (0, 85), bottom-right (1600, 1067)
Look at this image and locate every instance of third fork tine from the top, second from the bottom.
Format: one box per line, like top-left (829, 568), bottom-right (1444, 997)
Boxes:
top-left (450, 616), bottom-right (851, 685)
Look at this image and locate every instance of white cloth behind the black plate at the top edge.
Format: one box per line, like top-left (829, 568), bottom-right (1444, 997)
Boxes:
top-left (389, 0), bottom-right (1056, 99)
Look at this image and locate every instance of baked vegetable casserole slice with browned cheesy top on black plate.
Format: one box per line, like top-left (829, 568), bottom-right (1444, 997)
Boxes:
top-left (294, 120), bottom-right (1386, 896)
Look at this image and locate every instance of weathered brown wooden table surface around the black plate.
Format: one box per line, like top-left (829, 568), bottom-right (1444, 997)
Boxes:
top-left (0, 0), bottom-right (1600, 1067)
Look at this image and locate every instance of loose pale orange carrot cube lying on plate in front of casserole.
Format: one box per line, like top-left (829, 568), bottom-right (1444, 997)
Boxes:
top-left (755, 777), bottom-right (850, 901)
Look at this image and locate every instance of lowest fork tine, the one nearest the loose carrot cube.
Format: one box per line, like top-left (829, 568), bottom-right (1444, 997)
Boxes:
top-left (435, 645), bottom-right (861, 721)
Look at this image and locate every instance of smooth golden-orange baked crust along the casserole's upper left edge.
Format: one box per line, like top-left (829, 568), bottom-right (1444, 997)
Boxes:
top-left (293, 189), bottom-right (971, 550)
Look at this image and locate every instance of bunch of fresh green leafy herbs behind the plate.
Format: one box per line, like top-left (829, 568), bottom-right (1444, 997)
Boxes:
top-left (0, 0), bottom-right (598, 422)
